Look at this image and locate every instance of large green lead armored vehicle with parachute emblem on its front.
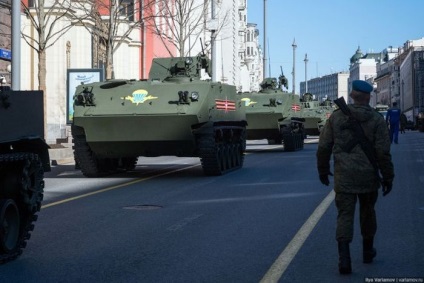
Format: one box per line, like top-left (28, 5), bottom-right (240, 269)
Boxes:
top-left (72, 55), bottom-right (246, 177)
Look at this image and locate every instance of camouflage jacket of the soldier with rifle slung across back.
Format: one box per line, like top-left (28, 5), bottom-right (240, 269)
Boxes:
top-left (316, 104), bottom-right (394, 193)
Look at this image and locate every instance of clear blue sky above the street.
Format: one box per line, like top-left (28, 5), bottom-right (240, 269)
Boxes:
top-left (247, 0), bottom-right (424, 92)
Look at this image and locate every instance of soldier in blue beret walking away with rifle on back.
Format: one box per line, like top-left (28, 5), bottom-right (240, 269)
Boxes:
top-left (316, 80), bottom-right (394, 274)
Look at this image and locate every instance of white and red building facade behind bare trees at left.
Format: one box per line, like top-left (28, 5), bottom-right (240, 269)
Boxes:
top-left (14, 0), bottom-right (175, 144)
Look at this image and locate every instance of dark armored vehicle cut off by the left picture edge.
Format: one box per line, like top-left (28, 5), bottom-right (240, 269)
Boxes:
top-left (0, 82), bottom-right (50, 264)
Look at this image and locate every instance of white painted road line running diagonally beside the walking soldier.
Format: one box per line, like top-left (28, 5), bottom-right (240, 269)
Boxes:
top-left (260, 190), bottom-right (334, 283)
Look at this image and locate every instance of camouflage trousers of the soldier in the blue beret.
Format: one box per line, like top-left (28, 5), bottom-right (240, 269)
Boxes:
top-left (335, 191), bottom-right (378, 242)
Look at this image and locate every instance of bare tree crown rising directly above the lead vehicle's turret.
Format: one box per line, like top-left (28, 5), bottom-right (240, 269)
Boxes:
top-left (148, 0), bottom-right (229, 56)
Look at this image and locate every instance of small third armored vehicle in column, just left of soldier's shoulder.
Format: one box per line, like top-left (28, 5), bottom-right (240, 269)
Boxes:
top-left (299, 92), bottom-right (334, 136)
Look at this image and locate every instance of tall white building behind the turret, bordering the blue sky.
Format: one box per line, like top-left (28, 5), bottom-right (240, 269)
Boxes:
top-left (191, 0), bottom-right (263, 92)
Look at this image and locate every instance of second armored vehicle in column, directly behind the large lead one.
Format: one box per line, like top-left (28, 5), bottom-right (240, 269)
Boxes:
top-left (241, 75), bottom-right (304, 151)
